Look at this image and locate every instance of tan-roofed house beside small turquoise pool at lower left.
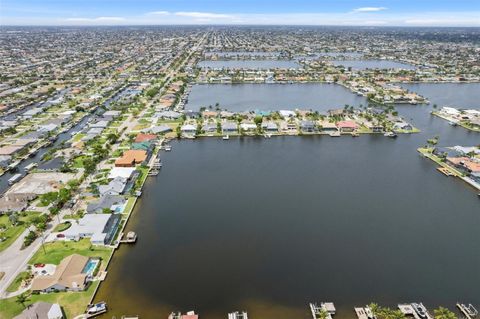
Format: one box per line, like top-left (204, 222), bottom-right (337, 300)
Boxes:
top-left (31, 254), bottom-right (90, 293)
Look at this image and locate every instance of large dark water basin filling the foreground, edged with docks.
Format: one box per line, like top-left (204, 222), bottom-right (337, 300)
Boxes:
top-left (96, 86), bottom-right (480, 319)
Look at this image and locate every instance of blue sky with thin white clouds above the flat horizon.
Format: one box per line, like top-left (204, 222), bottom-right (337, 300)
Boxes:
top-left (0, 0), bottom-right (480, 27)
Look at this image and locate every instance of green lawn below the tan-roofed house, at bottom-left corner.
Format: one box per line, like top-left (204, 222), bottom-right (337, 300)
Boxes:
top-left (0, 281), bottom-right (99, 319)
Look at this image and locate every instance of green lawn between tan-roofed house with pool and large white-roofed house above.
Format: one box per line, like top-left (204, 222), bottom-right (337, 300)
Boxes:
top-left (29, 238), bottom-right (112, 265)
